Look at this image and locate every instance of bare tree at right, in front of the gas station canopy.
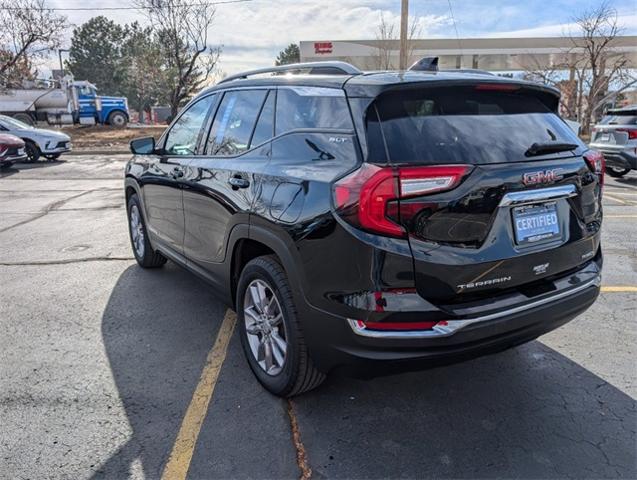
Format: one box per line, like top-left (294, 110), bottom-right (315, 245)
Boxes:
top-left (522, 2), bottom-right (635, 135)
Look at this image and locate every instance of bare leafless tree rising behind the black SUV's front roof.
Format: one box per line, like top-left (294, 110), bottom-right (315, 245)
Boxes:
top-left (136, 0), bottom-right (221, 116)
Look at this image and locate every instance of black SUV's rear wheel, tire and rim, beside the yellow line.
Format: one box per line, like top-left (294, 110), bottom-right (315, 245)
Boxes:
top-left (237, 255), bottom-right (325, 397)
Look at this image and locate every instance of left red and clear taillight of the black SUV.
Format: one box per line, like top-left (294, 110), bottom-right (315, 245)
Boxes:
top-left (333, 163), bottom-right (471, 237)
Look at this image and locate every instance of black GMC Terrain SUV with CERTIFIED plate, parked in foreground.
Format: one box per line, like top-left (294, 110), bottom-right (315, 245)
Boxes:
top-left (125, 62), bottom-right (604, 396)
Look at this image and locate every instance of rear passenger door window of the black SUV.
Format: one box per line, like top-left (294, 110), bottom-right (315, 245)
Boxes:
top-left (206, 90), bottom-right (268, 156)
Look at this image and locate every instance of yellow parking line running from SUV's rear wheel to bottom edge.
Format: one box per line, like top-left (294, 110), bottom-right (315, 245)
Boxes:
top-left (161, 310), bottom-right (237, 480)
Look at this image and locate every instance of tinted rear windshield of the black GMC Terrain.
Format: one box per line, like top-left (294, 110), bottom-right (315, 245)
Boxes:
top-left (367, 87), bottom-right (580, 164)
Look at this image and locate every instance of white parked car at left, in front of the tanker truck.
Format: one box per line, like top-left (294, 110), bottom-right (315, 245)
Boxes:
top-left (0, 115), bottom-right (72, 162)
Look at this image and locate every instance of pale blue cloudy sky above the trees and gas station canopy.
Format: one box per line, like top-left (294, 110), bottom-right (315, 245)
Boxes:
top-left (46, 0), bottom-right (637, 74)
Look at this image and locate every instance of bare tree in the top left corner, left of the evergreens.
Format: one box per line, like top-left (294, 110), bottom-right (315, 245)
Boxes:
top-left (0, 0), bottom-right (68, 86)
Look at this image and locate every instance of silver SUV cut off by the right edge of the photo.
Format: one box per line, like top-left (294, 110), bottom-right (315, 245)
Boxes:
top-left (590, 105), bottom-right (637, 177)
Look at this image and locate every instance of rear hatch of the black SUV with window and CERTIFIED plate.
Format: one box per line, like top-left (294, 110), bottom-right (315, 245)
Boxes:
top-left (367, 81), bottom-right (603, 305)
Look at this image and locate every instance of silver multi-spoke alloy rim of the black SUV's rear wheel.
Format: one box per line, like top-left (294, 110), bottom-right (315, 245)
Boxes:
top-left (243, 280), bottom-right (288, 376)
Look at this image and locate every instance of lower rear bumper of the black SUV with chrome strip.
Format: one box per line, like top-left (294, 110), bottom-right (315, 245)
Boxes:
top-left (306, 270), bottom-right (600, 377)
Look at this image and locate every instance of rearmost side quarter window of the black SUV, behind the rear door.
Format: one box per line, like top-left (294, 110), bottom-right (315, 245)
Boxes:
top-left (276, 87), bottom-right (354, 135)
